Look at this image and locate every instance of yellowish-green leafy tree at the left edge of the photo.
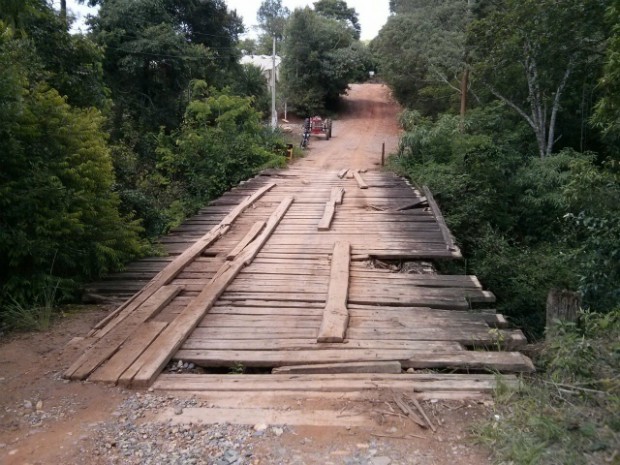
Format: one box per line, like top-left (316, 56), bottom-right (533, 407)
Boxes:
top-left (0, 22), bottom-right (143, 306)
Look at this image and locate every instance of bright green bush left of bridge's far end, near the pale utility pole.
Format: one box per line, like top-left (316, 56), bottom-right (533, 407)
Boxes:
top-left (151, 82), bottom-right (285, 224)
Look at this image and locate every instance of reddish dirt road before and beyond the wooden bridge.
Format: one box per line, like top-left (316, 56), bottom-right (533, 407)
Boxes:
top-left (0, 84), bottom-right (490, 465)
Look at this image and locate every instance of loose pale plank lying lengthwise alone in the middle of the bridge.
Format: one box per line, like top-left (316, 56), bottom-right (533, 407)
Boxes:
top-left (317, 242), bottom-right (351, 342)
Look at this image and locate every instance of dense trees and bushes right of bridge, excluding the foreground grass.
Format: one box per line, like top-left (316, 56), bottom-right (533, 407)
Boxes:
top-left (371, 0), bottom-right (620, 336)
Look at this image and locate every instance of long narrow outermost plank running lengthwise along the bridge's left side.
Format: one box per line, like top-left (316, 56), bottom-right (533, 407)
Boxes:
top-left (88, 183), bottom-right (276, 337)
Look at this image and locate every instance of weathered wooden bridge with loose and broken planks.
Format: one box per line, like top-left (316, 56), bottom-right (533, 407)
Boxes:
top-left (65, 165), bottom-right (533, 396)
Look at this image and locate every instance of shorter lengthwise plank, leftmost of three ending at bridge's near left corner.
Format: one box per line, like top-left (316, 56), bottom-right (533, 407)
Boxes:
top-left (63, 286), bottom-right (182, 380)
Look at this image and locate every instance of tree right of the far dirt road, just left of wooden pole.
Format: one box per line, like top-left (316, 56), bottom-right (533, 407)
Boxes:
top-left (371, 0), bottom-right (472, 114)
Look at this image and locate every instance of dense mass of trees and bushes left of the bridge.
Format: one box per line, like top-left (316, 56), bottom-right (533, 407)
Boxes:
top-left (0, 0), bottom-right (284, 329)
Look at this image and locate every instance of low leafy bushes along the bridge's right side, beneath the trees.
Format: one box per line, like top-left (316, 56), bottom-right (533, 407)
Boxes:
top-left (392, 110), bottom-right (620, 337)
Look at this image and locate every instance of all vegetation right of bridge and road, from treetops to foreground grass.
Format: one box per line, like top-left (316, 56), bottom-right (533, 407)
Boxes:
top-left (370, 0), bottom-right (620, 464)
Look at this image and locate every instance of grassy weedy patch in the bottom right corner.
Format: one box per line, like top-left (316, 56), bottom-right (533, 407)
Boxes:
top-left (475, 310), bottom-right (620, 465)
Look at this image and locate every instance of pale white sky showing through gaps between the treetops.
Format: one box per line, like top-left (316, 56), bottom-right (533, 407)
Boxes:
top-left (65, 0), bottom-right (389, 40)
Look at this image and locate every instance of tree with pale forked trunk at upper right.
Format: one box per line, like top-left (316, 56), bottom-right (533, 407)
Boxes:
top-left (469, 0), bottom-right (608, 157)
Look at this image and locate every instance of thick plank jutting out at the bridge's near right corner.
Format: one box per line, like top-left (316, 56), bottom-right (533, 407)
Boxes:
top-left (402, 350), bottom-right (535, 373)
